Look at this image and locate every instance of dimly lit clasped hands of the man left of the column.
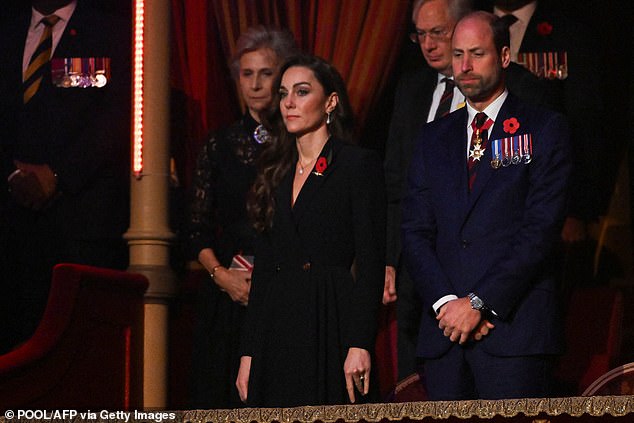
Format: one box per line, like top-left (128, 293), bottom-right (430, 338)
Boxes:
top-left (8, 160), bottom-right (57, 210)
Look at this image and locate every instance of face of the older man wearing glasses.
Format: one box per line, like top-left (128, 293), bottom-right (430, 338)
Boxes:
top-left (415, 0), bottom-right (456, 76)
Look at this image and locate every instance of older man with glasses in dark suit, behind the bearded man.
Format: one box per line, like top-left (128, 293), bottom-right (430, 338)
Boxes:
top-left (383, 0), bottom-right (554, 378)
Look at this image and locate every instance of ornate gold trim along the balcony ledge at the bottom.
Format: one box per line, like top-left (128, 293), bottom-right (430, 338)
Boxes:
top-left (179, 395), bottom-right (634, 423)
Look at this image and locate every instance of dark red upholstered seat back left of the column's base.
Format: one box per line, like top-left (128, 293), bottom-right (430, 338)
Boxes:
top-left (0, 264), bottom-right (148, 410)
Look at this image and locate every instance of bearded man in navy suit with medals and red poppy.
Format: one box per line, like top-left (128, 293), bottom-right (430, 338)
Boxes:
top-left (402, 12), bottom-right (571, 400)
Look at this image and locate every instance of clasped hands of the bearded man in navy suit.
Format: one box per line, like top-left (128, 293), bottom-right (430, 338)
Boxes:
top-left (436, 297), bottom-right (495, 344)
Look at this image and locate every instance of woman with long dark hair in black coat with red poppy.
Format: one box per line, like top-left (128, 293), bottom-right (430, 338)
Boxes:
top-left (236, 56), bottom-right (386, 407)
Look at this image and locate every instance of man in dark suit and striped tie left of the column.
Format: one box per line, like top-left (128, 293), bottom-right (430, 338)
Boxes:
top-left (0, 0), bottom-right (130, 351)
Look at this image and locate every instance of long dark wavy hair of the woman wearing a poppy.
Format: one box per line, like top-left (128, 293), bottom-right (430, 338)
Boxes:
top-left (247, 54), bottom-right (354, 232)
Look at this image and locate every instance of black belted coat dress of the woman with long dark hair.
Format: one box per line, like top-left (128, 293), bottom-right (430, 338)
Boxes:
top-left (241, 139), bottom-right (386, 407)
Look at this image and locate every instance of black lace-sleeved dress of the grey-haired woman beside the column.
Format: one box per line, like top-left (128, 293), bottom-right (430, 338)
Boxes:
top-left (186, 113), bottom-right (261, 408)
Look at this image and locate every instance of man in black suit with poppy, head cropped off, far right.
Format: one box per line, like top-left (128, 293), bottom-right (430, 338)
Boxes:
top-left (493, 0), bottom-right (617, 291)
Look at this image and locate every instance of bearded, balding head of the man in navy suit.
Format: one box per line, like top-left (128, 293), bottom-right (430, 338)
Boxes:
top-left (452, 16), bottom-right (510, 110)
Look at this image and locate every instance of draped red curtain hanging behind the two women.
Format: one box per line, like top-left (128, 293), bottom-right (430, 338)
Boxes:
top-left (171, 0), bottom-right (410, 187)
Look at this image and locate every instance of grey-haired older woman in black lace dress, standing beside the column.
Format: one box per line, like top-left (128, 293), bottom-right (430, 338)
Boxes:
top-left (187, 26), bottom-right (295, 408)
